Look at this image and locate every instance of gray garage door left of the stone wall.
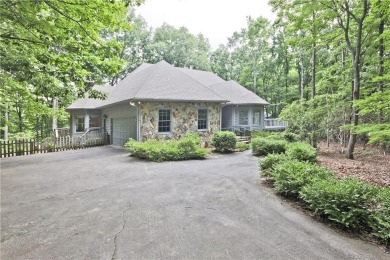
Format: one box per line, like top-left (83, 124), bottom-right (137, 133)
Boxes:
top-left (111, 116), bottom-right (137, 146)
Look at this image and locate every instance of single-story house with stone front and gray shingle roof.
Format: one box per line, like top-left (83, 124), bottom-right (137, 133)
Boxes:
top-left (67, 61), bottom-right (268, 145)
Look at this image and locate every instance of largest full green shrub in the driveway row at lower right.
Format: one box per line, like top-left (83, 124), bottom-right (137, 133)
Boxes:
top-left (300, 178), bottom-right (378, 230)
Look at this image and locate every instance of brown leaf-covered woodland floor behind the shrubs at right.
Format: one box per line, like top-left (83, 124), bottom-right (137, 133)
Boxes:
top-left (317, 143), bottom-right (390, 187)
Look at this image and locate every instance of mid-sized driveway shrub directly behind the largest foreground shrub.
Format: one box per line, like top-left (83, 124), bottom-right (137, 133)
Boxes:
top-left (271, 159), bottom-right (334, 197)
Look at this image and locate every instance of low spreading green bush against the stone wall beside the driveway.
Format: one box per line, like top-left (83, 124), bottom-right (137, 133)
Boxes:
top-left (125, 135), bottom-right (209, 162)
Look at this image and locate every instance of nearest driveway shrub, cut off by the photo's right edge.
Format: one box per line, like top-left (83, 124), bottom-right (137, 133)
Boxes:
top-left (370, 187), bottom-right (390, 246)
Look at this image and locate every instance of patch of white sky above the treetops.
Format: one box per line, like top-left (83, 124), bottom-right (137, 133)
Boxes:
top-left (136, 0), bottom-right (276, 49)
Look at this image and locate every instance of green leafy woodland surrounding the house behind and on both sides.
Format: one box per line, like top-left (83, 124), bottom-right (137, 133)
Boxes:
top-left (0, 0), bottom-right (390, 159)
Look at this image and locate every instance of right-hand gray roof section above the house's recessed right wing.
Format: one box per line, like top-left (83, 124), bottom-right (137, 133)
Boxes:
top-left (209, 80), bottom-right (269, 105)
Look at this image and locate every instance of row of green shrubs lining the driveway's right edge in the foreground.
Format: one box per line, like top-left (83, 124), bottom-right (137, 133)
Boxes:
top-left (259, 143), bottom-right (390, 246)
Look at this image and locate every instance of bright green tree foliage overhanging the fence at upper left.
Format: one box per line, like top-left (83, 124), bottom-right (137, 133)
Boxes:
top-left (0, 0), bottom-right (139, 139)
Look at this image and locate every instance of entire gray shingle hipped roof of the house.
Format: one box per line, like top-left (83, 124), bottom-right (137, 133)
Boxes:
top-left (68, 61), bottom-right (268, 109)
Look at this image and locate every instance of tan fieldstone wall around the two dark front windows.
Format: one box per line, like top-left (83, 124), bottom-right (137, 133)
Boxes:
top-left (140, 102), bottom-right (220, 141)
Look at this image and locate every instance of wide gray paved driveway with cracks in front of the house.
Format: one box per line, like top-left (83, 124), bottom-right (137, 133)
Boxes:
top-left (1, 146), bottom-right (389, 260)
